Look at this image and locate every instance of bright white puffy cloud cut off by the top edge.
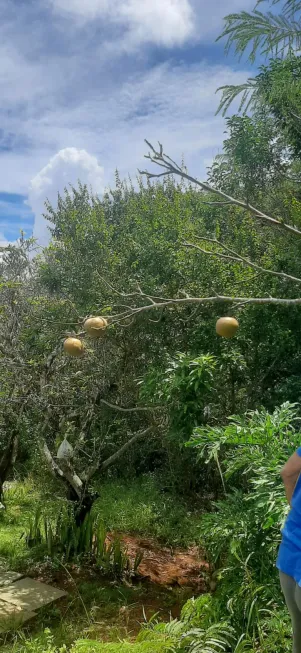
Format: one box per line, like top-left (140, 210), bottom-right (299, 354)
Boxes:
top-left (50, 0), bottom-right (194, 47)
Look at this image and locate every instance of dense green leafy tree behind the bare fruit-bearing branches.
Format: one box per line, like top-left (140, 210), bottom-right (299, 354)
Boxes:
top-left (35, 141), bottom-right (300, 468)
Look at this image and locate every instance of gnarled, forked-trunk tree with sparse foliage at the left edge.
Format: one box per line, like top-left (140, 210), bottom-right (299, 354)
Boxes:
top-left (0, 238), bottom-right (155, 521)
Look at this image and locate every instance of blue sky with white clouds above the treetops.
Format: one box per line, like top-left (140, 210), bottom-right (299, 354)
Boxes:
top-left (0, 0), bottom-right (254, 243)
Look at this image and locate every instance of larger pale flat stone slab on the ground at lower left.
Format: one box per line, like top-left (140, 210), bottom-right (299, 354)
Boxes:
top-left (0, 578), bottom-right (66, 612)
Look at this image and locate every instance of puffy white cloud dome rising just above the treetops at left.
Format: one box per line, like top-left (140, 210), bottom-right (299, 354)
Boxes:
top-left (28, 147), bottom-right (103, 245)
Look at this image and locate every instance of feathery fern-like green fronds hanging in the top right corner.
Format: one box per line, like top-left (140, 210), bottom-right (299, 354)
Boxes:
top-left (218, 0), bottom-right (301, 118)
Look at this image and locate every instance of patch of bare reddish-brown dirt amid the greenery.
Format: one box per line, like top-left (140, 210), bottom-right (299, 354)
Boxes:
top-left (107, 535), bottom-right (209, 592)
